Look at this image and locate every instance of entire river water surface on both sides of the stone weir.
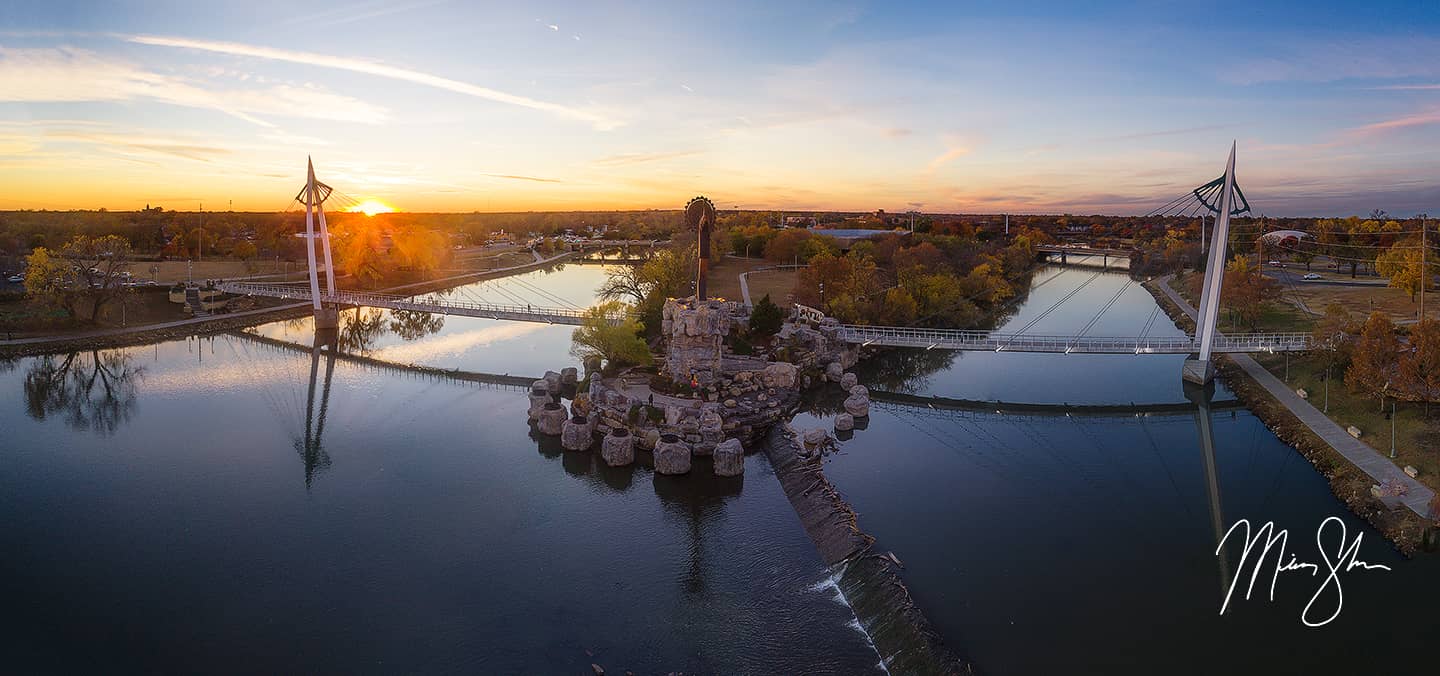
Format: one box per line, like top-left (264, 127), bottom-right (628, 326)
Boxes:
top-left (0, 265), bottom-right (1440, 675)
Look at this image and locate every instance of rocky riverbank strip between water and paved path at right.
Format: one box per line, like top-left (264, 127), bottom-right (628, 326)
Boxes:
top-left (1145, 277), bottom-right (1431, 555)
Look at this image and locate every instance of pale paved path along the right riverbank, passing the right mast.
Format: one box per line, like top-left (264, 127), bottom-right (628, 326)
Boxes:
top-left (1156, 275), bottom-right (1434, 517)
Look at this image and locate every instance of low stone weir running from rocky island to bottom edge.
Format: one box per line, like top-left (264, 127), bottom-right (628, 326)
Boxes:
top-left (765, 425), bottom-right (978, 675)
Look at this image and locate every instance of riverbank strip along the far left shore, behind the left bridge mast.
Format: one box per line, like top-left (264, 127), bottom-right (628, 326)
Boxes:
top-left (0, 252), bottom-right (575, 359)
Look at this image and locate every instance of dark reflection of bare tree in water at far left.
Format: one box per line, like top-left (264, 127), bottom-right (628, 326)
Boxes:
top-left (21, 344), bottom-right (145, 435)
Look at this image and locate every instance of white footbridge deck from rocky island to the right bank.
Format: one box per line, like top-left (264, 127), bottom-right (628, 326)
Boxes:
top-left (840, 324), bottom-right (1310, 355)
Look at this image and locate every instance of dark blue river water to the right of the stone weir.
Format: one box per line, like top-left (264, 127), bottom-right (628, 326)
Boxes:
top-left (793, 268), bottom-right (1440, 675)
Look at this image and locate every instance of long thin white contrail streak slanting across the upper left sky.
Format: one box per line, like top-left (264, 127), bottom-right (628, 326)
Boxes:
top-left (130, 35), bottom-right (621, 130)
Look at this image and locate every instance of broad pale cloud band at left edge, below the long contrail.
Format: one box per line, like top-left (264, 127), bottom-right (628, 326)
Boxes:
top-left (0, 48), bottom-right (386, 127)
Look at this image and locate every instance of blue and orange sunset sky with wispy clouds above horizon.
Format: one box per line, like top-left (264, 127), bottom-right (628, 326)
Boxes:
top-left (0, 0), bottom-right (1440, 216)
